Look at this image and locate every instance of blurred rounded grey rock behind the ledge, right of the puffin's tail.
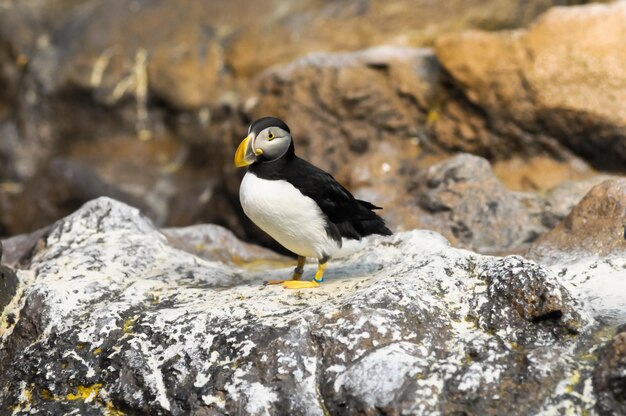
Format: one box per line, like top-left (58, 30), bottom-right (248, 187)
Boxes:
top-left (410, 154), bottom-right (606, 253)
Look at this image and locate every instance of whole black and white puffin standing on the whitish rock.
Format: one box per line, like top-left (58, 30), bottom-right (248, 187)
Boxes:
top-left (235, 117), bottom-right (391, 289)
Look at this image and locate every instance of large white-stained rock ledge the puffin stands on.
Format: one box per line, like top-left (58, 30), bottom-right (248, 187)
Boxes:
top-left (0, 198), bottom-right (626, 415)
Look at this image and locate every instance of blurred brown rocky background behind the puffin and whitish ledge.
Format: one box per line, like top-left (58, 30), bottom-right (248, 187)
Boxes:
top-left (0, 0), bottom-right (626, 253)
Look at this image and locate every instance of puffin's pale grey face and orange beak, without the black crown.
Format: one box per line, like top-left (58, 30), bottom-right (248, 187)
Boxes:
top-left (235, 126), bottom-right (292, 167)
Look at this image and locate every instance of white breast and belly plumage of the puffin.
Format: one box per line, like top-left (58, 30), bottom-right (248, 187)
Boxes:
top-left (239, 172), bottom-right (340, 259)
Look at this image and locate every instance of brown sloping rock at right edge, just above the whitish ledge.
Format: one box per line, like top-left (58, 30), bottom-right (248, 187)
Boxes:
top-left (529, 178), bottom-right (626, 262)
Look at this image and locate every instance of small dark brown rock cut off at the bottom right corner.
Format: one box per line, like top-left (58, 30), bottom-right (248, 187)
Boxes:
top-left (593, 326), bottom-right (626, 415)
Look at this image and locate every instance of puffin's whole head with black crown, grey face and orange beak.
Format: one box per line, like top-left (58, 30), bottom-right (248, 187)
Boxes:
top-left (235, 117), bottom-right (293, 168)
